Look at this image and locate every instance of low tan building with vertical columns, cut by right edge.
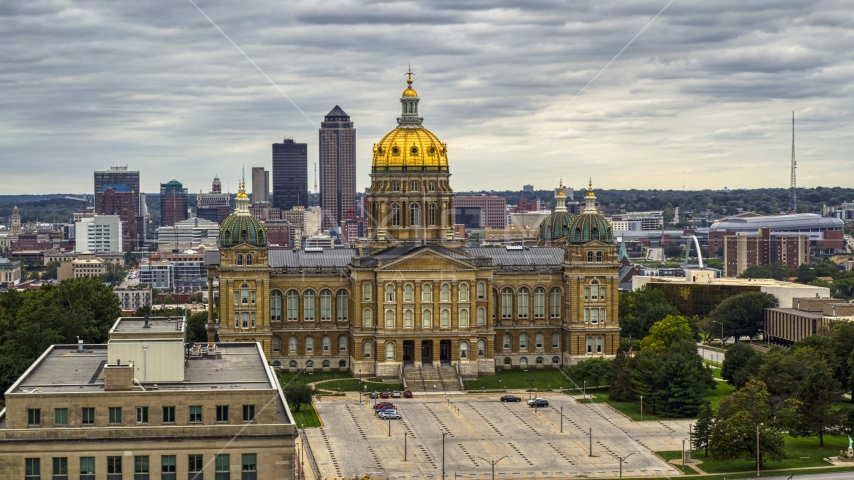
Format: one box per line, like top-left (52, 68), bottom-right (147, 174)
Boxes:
top-left (765, 297), bottom-right (854, 347)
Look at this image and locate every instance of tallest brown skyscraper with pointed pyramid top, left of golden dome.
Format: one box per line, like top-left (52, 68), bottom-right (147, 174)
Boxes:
top-left (320, 105), bottom-right (356, 229)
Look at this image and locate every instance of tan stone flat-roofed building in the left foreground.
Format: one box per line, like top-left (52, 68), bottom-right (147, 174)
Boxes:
top-left (0, 317), bottom-right (297, 480)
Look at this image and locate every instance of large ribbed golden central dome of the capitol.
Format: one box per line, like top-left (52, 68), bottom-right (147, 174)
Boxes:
top-left (372, 127), bottom-right (448, 171)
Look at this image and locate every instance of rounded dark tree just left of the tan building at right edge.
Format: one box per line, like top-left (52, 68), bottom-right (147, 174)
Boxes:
top-left (709, 292), bottom-right (779, 340)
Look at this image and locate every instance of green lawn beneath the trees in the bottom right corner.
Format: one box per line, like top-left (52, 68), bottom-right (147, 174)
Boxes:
top-left (656, 436), bottom-right (848, 473)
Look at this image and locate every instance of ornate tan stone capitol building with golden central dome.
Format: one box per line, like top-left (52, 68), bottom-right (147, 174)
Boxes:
top-left (205, 73), bottom-right (620, 378)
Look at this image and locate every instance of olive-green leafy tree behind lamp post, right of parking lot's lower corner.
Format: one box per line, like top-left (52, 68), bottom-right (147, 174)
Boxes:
top-left (709, 380), bottom-right (786, 467)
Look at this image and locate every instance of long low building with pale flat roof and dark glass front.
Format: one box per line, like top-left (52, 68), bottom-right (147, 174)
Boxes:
top-left (632, 269), bottom-right (830, 317)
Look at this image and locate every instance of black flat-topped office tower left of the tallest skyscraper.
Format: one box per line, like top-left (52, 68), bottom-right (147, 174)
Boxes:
top-left (273, 138), bottom-right (308, 212)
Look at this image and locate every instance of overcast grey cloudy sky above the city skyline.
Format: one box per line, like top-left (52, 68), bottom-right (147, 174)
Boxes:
top-left (0, 0), bottom-right (854, 194)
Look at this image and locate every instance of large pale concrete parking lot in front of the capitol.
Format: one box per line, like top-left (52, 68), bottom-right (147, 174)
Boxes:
top-left (306, 395), bottom-right (690, 479)
